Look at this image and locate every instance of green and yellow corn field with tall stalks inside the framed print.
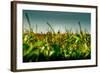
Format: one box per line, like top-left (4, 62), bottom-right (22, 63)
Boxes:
top-left (23, 15), bottom-right (91, 62)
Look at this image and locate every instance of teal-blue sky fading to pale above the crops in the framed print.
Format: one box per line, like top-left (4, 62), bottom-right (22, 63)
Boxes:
top-left (23, 10), bottom-right (91, 33)
